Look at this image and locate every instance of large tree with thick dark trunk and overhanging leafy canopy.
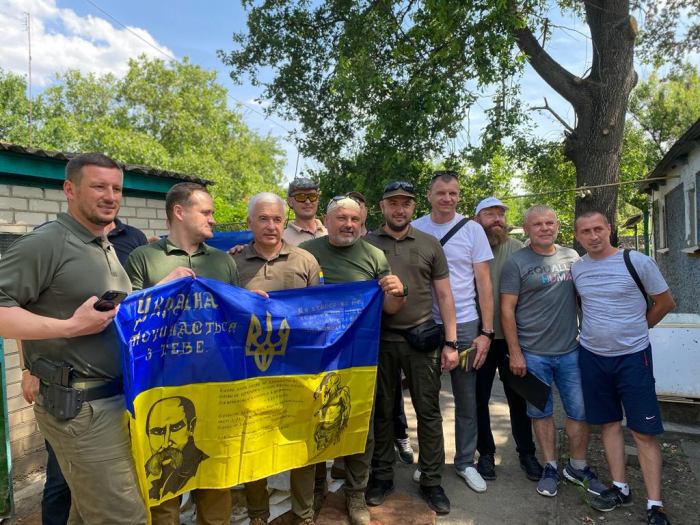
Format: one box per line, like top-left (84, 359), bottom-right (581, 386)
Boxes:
top-left (220, 0), bottom-right (698, 242)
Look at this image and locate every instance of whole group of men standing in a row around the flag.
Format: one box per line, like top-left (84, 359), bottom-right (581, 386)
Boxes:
top-left (0, 154), bottom-right (674, 525)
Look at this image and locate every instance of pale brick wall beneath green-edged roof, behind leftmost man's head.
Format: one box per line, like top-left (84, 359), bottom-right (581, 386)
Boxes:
top-left (0, 184), bottom-right (167, 237)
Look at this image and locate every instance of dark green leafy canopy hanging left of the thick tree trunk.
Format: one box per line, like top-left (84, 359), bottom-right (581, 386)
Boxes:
top-left (219, 0), bottom-right (541, 168)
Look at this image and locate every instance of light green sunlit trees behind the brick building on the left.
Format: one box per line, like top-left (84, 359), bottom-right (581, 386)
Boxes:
top-left (0, 56), bottom-right (284, 222)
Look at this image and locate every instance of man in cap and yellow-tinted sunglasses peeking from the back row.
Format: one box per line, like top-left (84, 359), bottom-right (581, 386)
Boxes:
top-left (282, 177), bottom-right (328, 246)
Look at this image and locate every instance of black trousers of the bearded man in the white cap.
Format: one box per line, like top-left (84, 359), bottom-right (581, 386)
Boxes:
top-left (476, 339), bottom-right (535, 456)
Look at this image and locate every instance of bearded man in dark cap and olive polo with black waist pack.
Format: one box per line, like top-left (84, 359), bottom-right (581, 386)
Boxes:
top-left (365, 181), bottom-right (459, 514)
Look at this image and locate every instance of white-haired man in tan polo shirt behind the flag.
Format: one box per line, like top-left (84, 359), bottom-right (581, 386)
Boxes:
top-left (233, 193), bottom-right (321, 525)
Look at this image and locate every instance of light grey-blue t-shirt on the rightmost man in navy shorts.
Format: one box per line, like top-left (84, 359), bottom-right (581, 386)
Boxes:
top-left (571, 250), bottom-right (668, 357)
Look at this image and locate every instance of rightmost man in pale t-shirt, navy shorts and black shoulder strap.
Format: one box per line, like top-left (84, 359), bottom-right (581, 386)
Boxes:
top-left (571, 211), bottom-right (675, 525)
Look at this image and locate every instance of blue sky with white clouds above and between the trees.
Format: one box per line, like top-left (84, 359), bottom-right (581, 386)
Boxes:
top-left (0, 0), bottom-right (664, 183)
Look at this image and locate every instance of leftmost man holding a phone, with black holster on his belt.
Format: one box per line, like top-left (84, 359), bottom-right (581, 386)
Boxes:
top-left (0, 153), bottom-right (147, 525)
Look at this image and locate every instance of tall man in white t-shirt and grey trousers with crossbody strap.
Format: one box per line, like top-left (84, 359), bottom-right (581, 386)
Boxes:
top-left (413, 171), bottom-right (495, 492)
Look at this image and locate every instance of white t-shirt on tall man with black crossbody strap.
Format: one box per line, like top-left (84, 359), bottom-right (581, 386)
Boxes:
top-left (411, 213), bottom-right (493, 323)
